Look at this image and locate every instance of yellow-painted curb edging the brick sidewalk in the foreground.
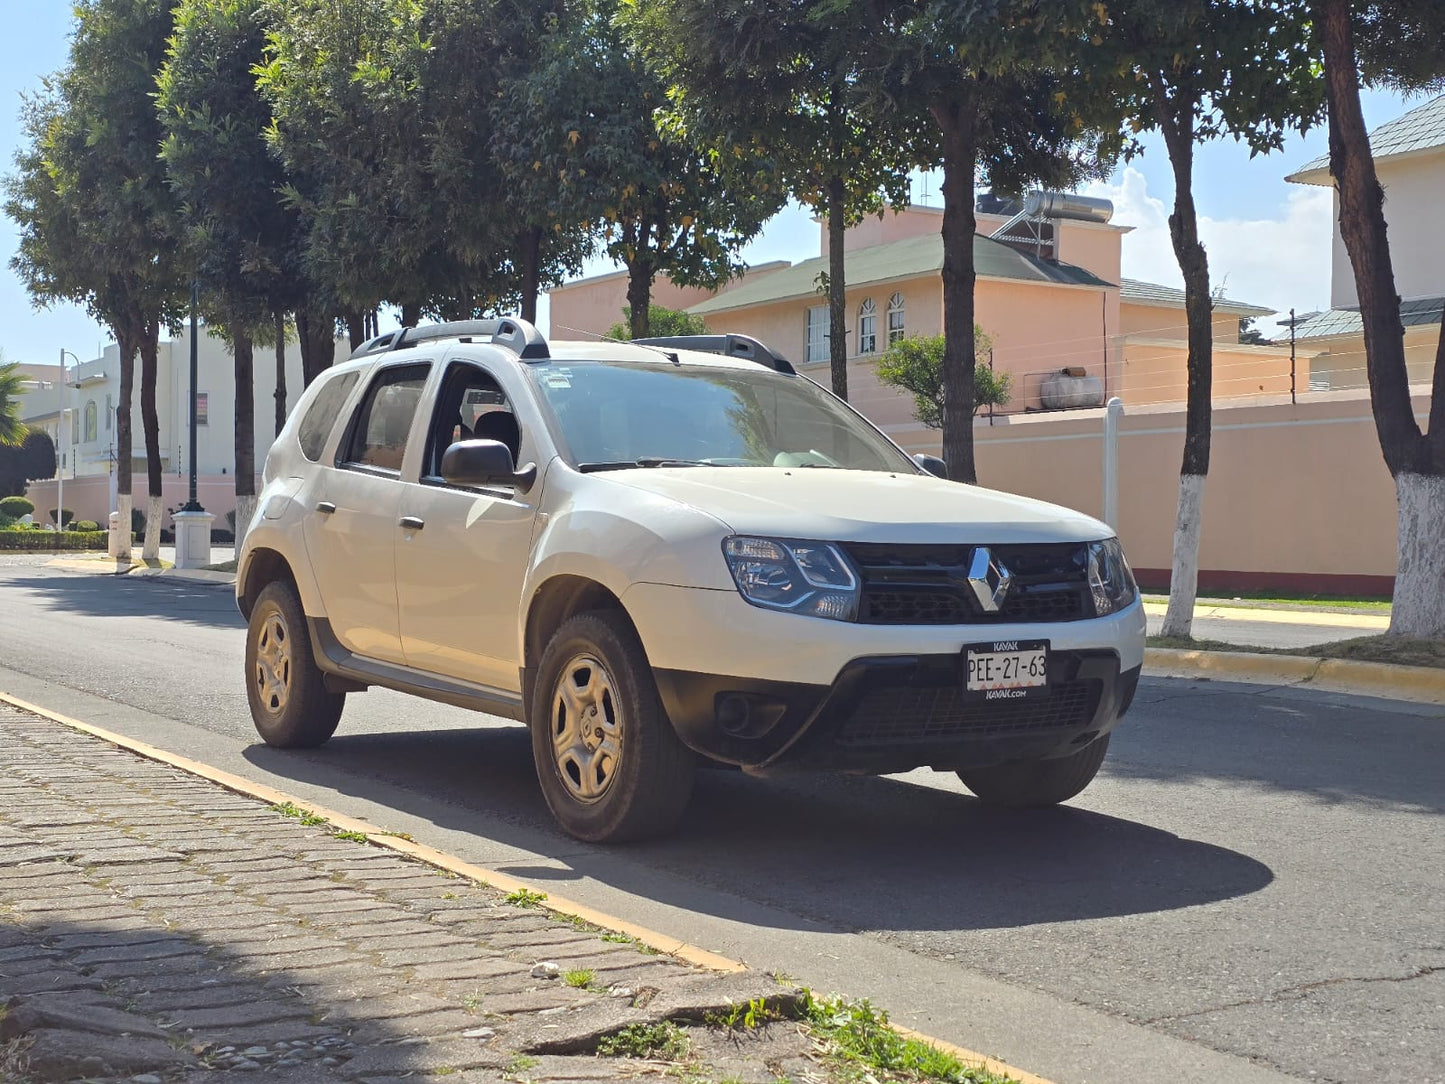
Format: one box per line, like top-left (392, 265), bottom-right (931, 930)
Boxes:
top-left (0, 692), bottom-right (1052, 1084)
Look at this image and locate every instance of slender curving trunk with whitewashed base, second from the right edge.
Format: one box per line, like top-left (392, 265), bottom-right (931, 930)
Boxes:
top-left (1159, 103), bottom-right (1214, 639)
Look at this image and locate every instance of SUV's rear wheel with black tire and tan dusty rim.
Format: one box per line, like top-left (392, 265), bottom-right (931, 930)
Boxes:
top-left (246, 581), bottom-right (347, 749)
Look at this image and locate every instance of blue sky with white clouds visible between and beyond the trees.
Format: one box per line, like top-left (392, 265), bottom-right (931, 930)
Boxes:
top-left (0, 0), bottom-right (1418, 363)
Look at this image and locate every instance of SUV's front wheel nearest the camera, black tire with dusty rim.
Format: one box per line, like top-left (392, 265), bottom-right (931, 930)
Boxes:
top-left (529, 610), bottom-right (696, 843)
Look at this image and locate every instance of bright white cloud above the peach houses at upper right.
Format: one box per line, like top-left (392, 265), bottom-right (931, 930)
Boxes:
top-left (1085, 166), bottom-right (1334, 317)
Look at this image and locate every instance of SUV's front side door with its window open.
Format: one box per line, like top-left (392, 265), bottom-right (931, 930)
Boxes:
top-left (396, 361), bottom-right (542, 692)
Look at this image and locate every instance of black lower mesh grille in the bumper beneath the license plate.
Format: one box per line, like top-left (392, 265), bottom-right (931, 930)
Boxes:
top-left (838, 681), bottom-right (1104, 746)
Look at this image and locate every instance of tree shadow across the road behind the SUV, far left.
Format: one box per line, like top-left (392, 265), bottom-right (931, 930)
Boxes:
top-left (0, 569), bottom-right (246, 629)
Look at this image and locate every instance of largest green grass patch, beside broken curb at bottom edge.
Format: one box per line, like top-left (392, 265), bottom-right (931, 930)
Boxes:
top-left (802, 993), bottom-right (1013, 1084)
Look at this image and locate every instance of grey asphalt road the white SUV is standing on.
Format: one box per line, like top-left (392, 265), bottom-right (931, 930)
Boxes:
top-left (0, 556), bottom-right (1445, 1084)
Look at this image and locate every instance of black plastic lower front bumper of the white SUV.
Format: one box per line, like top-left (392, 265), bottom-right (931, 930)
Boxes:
top-left (655, 650), bottom-right (1140, 773)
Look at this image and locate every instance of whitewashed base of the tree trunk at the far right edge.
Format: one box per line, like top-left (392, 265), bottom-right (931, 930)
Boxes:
top-left (1390, 473), bottom-right (1445, 639)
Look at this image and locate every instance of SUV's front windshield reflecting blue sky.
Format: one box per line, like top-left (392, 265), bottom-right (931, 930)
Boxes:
top-left (527, 361), bottom-right (916, 473)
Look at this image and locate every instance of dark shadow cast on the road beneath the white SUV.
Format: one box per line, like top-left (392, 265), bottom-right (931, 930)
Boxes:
top-left (246, 723), bottom-right (1273, 929)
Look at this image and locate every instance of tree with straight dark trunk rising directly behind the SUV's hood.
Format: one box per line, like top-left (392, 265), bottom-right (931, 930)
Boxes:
top-left (861, 0), bottom-right (1107, 481)
